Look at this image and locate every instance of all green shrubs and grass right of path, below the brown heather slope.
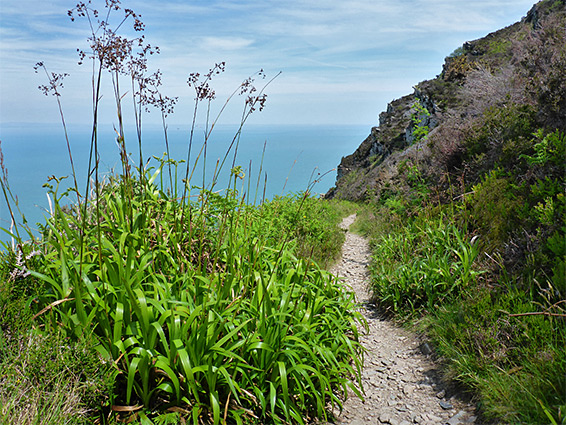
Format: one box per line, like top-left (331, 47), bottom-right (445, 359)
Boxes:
top-left (362, 120), bottom-right (566, 423)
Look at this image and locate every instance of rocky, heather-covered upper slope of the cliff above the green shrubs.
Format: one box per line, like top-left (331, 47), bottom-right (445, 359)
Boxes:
top-left (326, 0), bottom-right (566, 201)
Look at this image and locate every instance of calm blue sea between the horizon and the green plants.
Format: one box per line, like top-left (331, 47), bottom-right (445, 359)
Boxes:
top-left (0, 124), bottom-right (370, 242)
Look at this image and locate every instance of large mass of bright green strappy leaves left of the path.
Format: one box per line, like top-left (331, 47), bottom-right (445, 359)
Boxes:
top-left (0, 173), bottom-right (361, 423)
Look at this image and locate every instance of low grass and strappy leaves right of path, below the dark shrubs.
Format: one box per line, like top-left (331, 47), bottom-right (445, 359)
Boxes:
top-left (366, 191), bottom-right (566, 423)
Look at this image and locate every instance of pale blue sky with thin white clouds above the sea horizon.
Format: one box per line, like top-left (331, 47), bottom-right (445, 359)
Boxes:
top-left (0, 0), bottom-right (534, 127)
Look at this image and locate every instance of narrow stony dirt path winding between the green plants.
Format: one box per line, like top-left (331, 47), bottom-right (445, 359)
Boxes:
top-left (333, 215), bottom-right (478, 425)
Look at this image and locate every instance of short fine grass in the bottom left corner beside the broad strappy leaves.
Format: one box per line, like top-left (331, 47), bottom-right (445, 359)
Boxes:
top-left (0, 245), bottom-right (113, 425)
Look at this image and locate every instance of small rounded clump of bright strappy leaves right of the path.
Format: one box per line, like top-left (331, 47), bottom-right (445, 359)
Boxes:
top-left (371, 214), bottom-right (478, 315)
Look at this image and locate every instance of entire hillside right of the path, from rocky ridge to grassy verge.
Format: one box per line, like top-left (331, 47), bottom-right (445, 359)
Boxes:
top-left (329, 0), bottom-right (566, 423)
